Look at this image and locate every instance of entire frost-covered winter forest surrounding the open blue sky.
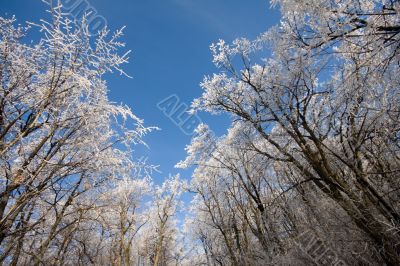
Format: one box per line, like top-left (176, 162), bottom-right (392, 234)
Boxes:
top-left (0, 0), bottom-right (400, 266)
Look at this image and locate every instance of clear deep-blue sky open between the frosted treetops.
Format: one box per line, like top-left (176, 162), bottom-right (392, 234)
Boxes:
top-left (0, 0), bottom-right (279, 203)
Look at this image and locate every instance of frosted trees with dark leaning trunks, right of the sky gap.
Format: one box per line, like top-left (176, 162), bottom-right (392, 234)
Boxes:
top-left (180, 0), bottom-right (400, 265)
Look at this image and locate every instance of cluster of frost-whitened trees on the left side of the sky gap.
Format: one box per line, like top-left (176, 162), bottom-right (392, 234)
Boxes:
top-left (0, 6), bottom-right (152, 265)
